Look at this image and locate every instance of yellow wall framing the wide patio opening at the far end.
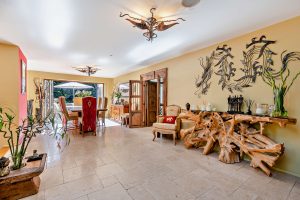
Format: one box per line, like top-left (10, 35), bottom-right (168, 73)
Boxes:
top-left (27, 71), bottom-right (113, 115)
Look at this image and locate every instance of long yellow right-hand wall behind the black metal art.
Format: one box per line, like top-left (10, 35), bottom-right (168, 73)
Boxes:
top-left (114, 17), bottom-right (300, 177)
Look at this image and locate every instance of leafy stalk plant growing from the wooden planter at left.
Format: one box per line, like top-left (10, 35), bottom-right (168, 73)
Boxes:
top-left (0, 107), bottom-right (66, 170)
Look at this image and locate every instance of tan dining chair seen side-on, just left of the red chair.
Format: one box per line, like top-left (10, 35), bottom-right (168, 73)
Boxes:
top-left (58, 96), bottom-right (78, 131)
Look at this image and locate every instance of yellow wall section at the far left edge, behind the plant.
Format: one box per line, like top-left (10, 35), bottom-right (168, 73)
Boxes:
top-left (0, 43), bottom-right (20, 147)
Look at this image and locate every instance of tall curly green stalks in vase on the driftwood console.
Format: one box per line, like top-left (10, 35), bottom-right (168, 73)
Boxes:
top-left (263, 52), bottom-right (300, 117)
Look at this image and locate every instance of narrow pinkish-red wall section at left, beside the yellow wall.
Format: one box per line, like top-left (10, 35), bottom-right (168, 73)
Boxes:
top-left (19, 48), bottom-right (27, 123)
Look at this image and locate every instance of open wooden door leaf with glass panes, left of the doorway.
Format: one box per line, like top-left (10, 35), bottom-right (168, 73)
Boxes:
top-left (129, 80), bottom-right (143, 128)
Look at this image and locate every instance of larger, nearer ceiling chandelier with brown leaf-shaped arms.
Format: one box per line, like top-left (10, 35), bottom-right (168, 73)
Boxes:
top-left (120, 8), bottom-right (185, 42)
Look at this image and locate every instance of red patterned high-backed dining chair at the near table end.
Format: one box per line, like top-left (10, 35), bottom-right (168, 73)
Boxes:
top-left (81, 97), bottom-right (97, 132)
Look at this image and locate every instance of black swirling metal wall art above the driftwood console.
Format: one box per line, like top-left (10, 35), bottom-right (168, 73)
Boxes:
top-left (195, 35), bottom-right (300, 97)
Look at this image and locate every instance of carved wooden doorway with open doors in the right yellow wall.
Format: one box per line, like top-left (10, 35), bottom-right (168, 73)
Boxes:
top-left (129, 68), bottom-right (168, 128)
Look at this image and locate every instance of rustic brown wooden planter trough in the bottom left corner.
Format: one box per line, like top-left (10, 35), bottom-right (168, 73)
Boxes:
top-left (0, 154), bottom-right (47, 199)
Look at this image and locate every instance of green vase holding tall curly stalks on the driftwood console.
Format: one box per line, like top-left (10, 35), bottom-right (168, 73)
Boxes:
top-left (272, 87), bottom-right (288, 117)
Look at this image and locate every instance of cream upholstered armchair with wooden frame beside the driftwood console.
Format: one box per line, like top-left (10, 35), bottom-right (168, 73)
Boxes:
top-left (152, 105), bottom-right (181, 145)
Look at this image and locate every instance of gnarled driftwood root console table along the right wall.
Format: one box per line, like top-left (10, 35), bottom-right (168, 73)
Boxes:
top-left (180, 112), bottom-right (297, 176)
